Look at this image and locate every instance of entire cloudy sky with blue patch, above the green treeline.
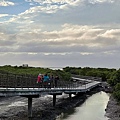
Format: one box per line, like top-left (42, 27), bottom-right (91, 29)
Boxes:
top-left (0, 0), bottom-right (120, 68)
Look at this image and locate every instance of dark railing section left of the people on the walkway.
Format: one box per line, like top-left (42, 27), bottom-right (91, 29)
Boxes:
top-left (0, 73), bottom-right (37, 88)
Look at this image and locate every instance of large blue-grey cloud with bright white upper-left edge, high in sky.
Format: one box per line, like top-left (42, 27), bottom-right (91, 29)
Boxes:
top-left (3, 0), bottom-right (120, 27)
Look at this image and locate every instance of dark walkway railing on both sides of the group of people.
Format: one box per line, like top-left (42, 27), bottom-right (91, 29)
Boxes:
top-left (0, 72), bottom-right (83, 88)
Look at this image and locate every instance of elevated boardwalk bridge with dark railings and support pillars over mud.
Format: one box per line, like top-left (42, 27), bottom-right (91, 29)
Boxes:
top-left (0, 72), bottom-right (101, 117)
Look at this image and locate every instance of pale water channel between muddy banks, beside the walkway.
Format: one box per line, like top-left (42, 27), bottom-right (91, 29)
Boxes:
top-left (56, 92), bottom-right (109, 120)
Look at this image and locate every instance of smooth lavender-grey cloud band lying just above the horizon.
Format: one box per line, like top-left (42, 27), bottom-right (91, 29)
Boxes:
top-left (0, 50), bottom-right (120, 68)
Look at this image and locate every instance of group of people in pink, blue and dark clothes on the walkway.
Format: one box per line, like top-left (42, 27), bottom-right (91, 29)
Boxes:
top-left (37, 74), bottom-right (59, 88)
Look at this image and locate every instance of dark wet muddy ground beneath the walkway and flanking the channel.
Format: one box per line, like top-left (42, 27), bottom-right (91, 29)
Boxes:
top-left (0, 89), bottom-right (120, 120)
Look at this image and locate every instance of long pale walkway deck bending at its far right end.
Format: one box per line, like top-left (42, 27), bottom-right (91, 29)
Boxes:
top-left (0, 81), bottom-right (101, 97)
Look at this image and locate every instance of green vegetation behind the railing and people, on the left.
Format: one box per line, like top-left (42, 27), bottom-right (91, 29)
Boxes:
top-left (0, 65), bottom-right (71, 80)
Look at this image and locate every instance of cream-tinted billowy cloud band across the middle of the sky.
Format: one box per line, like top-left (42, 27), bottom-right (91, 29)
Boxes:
top-left (0, 24), bottom-right (120, 54)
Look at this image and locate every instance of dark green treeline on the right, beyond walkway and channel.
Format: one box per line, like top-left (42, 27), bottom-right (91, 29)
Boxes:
top-left (63, 67), bottom-right (120, 101)
